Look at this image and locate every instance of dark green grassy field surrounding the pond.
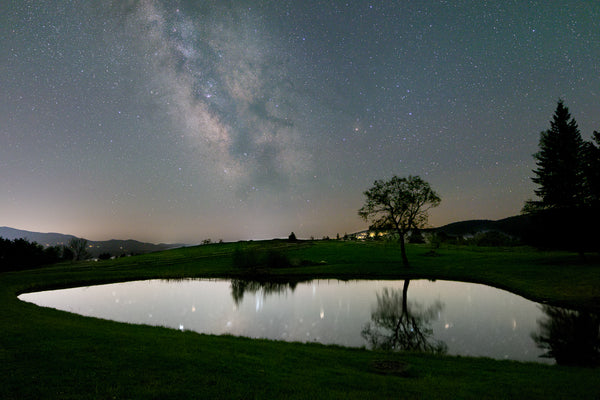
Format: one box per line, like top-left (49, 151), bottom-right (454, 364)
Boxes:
top-left (0, 241), bottom-right (600, 399)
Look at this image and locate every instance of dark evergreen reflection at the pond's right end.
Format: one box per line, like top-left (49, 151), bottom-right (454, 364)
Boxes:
top-left (531, 306), bottom-right (600, 366)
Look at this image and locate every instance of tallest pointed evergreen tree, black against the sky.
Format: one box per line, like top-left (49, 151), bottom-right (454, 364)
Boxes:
top-left (525, 100), bottom-right (584, 211)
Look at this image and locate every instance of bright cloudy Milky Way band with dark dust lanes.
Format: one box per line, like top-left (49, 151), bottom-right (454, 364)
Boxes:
top-left (127, 2), bottom-right (310, 189)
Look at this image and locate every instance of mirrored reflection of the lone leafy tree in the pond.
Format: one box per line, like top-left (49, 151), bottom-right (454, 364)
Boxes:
top-left (362, 280), bottom-right (447, 353)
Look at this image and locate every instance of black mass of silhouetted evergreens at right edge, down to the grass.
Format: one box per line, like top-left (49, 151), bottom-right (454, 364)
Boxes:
top-left (523, 100), bottom-right (600, 254)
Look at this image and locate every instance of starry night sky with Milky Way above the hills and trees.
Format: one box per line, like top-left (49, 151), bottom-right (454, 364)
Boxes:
top-left (0, 0), bottom-right (600, 244)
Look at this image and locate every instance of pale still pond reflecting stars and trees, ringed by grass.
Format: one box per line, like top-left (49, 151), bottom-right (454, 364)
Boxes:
top-left (19, 279), bottom-right (598, 363)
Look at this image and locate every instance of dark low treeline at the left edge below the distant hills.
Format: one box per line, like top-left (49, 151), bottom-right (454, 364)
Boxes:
top-left (0, 237), bottom-right (73, 271)
